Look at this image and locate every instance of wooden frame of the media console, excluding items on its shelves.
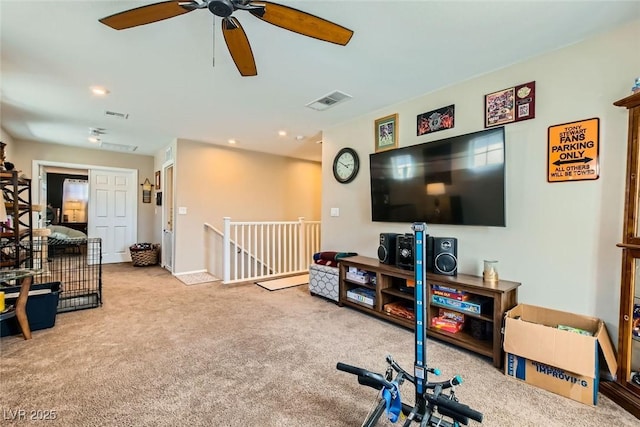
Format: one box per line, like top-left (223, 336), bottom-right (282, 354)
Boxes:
top-left (340, 256), bottom-right (520, 368)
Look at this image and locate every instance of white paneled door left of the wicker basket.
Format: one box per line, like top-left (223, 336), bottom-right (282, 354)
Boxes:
top-left (88, 169), bottom-right (138, 264)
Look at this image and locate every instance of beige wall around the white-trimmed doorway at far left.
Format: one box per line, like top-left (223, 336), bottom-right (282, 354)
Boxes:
top-left (7, 140), bottom-right (154, 242)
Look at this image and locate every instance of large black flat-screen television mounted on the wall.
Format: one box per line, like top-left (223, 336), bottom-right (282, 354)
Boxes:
top-left (369, 127), bottom-right (505, 227)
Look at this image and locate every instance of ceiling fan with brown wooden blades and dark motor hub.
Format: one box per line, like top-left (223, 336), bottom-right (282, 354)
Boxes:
top-left (99, 0), bottom-right (353, 76)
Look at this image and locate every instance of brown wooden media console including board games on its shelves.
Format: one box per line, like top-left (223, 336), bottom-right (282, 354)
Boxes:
top-left (339, 256), bottom-right (520, 368)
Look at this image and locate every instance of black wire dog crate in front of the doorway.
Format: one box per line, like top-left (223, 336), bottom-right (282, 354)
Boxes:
top-left (33, 238), bottom-right (102, 313)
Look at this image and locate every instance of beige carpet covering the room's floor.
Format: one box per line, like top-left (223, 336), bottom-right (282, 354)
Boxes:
top-left (0, 264), bottom-right (639, 427)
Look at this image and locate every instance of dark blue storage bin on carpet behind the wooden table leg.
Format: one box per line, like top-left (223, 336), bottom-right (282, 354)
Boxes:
top-left (0, 282), bottom-right (62, 337)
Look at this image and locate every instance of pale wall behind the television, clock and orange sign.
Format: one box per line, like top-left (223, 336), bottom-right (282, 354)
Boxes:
top-left (322, 21), bottom-right (640, 337)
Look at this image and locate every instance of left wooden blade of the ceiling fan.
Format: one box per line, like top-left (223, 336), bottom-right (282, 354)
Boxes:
top-left (99, 0), bottom-right (198, 30)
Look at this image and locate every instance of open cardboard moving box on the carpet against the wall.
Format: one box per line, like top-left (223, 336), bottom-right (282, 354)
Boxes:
top-left (504, 304), bottom-right (618, 405)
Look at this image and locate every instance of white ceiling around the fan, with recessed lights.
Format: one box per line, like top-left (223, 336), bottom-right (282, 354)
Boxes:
top-left (0, 0), bottom-right (640, 160)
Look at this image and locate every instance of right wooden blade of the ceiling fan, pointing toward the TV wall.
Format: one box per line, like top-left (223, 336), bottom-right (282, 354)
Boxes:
top-left (249, 1), bottom-right (353, 46)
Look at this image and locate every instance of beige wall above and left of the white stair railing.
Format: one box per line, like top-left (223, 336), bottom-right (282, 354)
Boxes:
top-left (171, 140), bottom-right (322, 274)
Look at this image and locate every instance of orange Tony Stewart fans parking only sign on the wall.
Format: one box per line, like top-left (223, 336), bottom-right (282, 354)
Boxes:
top-left (547, 118), bottom-right (600, 182)
